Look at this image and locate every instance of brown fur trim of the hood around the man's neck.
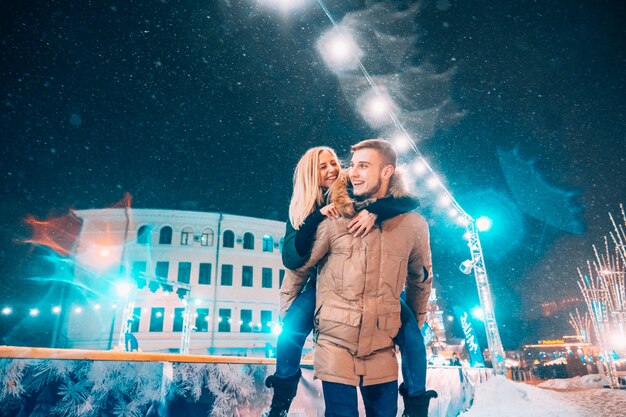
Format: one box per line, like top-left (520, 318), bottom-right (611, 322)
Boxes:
top-left (328, 167), bottom-right (412, 218)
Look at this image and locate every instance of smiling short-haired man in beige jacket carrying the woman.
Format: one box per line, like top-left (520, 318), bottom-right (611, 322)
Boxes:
top-left (281, 139), bottom-right (436, 417)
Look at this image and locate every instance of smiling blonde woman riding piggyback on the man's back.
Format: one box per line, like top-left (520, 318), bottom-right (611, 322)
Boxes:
top-left (265, 146), bottom-right (426, 417)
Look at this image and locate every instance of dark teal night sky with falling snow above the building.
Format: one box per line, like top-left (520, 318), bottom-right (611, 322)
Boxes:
top-left (0, 0), bottom-right (626, 348)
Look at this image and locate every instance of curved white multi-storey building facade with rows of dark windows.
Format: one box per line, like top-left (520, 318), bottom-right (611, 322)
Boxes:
top-left (65, 208), bottom-right (292, 356)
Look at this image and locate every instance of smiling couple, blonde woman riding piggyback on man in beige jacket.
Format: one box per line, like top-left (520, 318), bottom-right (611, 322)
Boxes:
top-left (266, 139), bottom-right (436, 417)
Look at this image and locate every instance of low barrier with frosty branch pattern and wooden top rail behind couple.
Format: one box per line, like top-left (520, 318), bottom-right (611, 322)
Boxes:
top-left (0, 346), bottom-right (493, 417)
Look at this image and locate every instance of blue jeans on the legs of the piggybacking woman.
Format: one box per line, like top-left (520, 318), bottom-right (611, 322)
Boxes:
top-left (276, 286), bottom-right (426, 396)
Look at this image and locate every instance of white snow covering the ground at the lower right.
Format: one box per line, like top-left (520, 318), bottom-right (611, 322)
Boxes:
top-left (461, 375), bottom-right (626, 417)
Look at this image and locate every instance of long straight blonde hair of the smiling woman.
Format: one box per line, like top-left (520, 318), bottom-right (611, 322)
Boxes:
top-left (289, 146), bottom-right (341, 230)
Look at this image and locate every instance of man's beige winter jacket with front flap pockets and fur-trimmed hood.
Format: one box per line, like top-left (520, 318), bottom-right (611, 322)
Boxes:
top-left (280, 171), bottom-right (432, 386)
